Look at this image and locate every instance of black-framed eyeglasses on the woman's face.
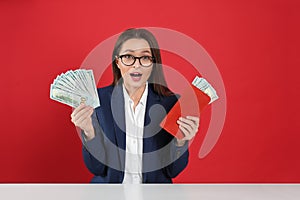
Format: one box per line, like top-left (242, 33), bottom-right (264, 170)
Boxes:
top-left (118, 54), bottom-right (155, 67)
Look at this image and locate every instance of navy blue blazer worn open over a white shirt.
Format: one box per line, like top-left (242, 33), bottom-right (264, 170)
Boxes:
top-left (83, 84), bottom-right (189, 183)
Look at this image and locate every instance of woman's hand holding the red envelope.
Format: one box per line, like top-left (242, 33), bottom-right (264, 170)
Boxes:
top-left (177, 116), bottom-right (200, 146)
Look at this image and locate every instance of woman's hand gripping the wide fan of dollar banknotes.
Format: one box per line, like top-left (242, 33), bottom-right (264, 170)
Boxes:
top-left (71, 103), bottom-right (95, 140)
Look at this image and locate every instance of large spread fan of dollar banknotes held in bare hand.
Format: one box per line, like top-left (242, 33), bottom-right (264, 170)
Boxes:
top-left (50, 69), bottom-right (100, 108)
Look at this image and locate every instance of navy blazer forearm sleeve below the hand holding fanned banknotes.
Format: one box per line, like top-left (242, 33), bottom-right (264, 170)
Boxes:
top-left (81, 111), bottom-right (107, 176)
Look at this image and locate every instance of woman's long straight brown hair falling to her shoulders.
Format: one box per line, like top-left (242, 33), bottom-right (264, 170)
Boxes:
top-left (112, 28), bottom-right (173, 96)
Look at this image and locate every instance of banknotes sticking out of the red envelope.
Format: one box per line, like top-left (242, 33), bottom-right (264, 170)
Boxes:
top-left (192, 76), bottom-right (219, 104)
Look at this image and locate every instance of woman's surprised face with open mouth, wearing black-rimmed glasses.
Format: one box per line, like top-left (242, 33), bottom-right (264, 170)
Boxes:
top-left (116, 39), bottom-right (153, 90)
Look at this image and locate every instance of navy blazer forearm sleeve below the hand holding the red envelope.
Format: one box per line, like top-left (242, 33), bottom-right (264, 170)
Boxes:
top-left (164, 138), bottom-right (189, 178)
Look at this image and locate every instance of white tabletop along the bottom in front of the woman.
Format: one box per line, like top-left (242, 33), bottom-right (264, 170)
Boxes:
top-left (0, 184), bottom-right (300, 200)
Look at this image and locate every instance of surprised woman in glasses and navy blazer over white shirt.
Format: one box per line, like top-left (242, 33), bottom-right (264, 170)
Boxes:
top-left (71, 29), bottom-right (199, 183)
